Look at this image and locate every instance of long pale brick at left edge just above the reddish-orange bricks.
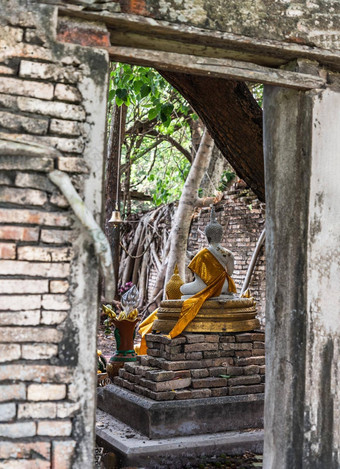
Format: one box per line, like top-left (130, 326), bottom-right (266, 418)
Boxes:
top-left (0, 208), bottom-right (73, 227)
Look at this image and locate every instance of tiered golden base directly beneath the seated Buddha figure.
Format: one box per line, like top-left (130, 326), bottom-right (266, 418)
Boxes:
top-left (153, 298), bottom-right (260, 334)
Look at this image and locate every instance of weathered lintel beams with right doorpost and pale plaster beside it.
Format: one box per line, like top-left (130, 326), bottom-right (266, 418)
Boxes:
top-left (58, 8), bottom-right (340, 469)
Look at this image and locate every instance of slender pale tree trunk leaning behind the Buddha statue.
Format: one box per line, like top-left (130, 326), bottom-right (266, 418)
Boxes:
top-left (165, 129), bottom-right (214, 284)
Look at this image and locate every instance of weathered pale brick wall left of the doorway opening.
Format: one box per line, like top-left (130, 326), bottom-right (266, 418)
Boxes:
top-left (0, 2), bottom-right (108, 469)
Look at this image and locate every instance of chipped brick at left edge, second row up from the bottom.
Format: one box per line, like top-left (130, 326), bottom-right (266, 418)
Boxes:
top-left (0, 441), bottom-right (51, 462)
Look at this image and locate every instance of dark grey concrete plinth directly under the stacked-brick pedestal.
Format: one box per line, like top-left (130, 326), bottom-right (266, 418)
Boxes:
top-left (97, 385), bottom-right (264, 439)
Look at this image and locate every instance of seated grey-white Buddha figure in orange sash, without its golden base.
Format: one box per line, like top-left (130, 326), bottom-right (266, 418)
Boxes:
top-left (180, 207), bottom-right (236, 300)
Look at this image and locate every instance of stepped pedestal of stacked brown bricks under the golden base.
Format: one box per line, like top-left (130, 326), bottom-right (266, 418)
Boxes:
top-left (114, 331), bottom-right (265, 401)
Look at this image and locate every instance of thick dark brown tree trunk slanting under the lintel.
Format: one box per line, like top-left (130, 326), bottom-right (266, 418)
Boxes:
top-left (159, 71), bottom-right (265, 201)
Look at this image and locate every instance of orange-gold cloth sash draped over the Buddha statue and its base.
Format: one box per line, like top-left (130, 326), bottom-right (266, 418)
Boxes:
top-left (168, 248), bottom-right (236, 339)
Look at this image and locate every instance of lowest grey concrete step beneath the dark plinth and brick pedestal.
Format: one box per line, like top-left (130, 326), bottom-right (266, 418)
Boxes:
top-left (96, 410), bottom-right (263, 469)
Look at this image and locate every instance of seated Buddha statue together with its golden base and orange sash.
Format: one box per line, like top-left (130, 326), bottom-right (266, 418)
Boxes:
top-left (152, 207), bottom-right (260, 338)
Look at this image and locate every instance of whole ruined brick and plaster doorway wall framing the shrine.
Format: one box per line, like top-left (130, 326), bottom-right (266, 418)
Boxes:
top-left (0, 0), bottom-right (340, 469)
